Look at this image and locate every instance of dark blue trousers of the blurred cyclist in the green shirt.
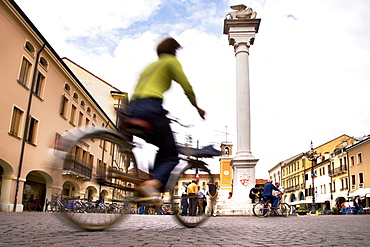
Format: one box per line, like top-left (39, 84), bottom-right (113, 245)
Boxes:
top-left (127, 98), bottom-right (179, 191)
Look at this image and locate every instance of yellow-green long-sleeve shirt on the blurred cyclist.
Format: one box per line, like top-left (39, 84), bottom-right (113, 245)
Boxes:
top-left (131, 54), bottom-right (196, 106)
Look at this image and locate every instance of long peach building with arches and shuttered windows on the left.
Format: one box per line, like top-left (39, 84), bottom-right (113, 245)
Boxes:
top-left (0, 0), bottom-right (125, 211)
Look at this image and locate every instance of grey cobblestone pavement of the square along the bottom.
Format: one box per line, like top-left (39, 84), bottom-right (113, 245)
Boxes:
top-left (0, 212), bottom-right (370, 247)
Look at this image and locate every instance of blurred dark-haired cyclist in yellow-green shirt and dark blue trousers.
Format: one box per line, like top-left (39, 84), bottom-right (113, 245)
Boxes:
top-left (123, 38), bottom-right (205, 200)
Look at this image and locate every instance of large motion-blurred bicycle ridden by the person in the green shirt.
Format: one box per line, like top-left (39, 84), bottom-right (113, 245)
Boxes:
top-left (55, 118), bottom-right (221, 230)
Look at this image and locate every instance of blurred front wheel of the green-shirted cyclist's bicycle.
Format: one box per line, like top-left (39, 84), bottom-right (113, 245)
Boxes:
top-left (169, 160), bottom-right (214, 228)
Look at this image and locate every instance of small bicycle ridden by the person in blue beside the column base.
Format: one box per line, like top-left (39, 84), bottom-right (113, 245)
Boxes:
top-left (253, 198), bottom-right (290, 217)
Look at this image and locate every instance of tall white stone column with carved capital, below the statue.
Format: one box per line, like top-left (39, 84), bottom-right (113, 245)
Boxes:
top-left (224, 18), bottom-right (261, 202)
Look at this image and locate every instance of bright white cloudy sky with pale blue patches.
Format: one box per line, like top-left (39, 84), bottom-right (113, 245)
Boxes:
top-left (16, 0), bottom-right (370, 178)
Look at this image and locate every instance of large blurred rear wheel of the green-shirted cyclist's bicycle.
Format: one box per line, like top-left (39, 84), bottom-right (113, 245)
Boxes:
top-left (52, 127), bottom-right (138, 231)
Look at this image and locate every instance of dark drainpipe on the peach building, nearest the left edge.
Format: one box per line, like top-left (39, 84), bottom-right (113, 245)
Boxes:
top-left (13, 43), bottom-right (45, 212)
